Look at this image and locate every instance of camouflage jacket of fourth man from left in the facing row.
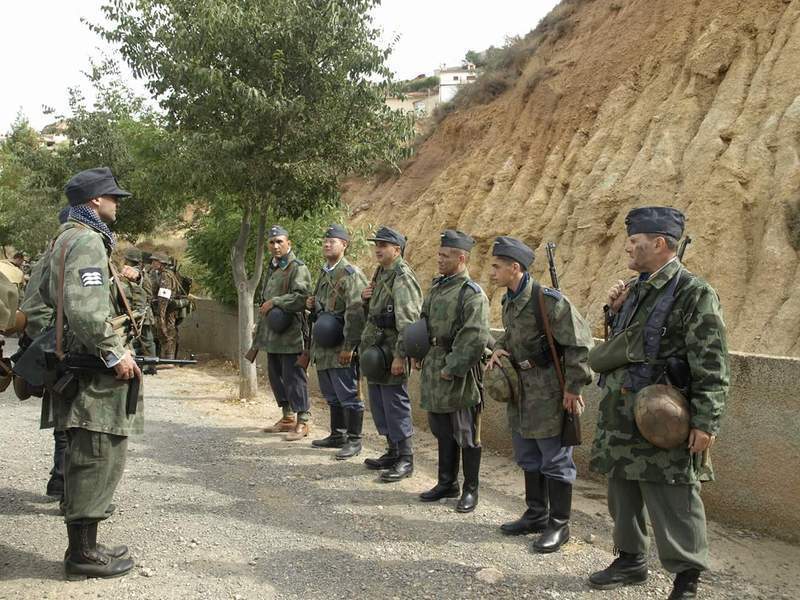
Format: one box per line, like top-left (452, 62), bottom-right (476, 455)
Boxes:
top-left (420, 271), bottom-right (489, 413)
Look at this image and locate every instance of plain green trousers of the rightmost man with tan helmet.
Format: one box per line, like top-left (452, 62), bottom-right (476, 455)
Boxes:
top-left (608, 477), bottom-right (708, 573)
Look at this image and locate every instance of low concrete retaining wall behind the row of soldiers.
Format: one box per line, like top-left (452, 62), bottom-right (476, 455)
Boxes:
top-left (181, 300), bottom-right (800, 542)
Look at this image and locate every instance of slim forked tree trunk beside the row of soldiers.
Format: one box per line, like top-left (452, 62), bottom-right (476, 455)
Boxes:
top-left (231, 205), bottom-right (266, 398)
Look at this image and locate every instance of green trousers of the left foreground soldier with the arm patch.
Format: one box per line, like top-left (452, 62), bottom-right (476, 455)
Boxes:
top-left (64, 427), bottom-right (128, 524)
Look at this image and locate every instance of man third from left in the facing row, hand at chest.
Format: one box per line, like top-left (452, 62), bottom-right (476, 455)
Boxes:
top-left (359, 227), bottom-right (422, 482)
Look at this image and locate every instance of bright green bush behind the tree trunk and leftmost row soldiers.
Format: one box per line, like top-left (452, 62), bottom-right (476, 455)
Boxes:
top-left (188, 203), bottom-right (370, 306)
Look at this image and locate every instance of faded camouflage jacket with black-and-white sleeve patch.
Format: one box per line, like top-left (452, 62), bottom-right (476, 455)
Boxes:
top-left (39, 221), bottom-right (144, 436)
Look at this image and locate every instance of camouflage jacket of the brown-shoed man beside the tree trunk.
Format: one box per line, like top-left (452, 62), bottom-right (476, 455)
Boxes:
top-left (253, 251), bottom-right (311, 354)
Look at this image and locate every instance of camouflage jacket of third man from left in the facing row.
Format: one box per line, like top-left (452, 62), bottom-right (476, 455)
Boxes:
top-left (360, 257), bottom-right (422, 385)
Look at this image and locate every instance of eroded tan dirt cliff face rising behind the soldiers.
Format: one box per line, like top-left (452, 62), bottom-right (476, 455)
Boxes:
top-left (345, 0), bottom-right (800, 355)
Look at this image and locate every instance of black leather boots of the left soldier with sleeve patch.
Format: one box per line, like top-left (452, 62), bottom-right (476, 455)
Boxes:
top-left (64, 523), bottom-right (133, 581)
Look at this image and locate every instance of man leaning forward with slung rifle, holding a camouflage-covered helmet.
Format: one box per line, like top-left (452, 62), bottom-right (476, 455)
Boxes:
top-left (489, 237), bottom-right (592, 552)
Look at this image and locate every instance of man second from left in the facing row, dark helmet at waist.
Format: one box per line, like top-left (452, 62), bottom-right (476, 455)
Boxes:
top-left (306, 225), bottom-right (367, 460)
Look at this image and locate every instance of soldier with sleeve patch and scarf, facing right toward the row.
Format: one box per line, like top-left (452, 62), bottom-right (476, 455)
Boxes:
top-left (39, 167), bottom-right (143, 579)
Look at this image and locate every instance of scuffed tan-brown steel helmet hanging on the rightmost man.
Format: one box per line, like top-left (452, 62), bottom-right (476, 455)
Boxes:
top-left (633, 384), bottom-right (689, 450)
